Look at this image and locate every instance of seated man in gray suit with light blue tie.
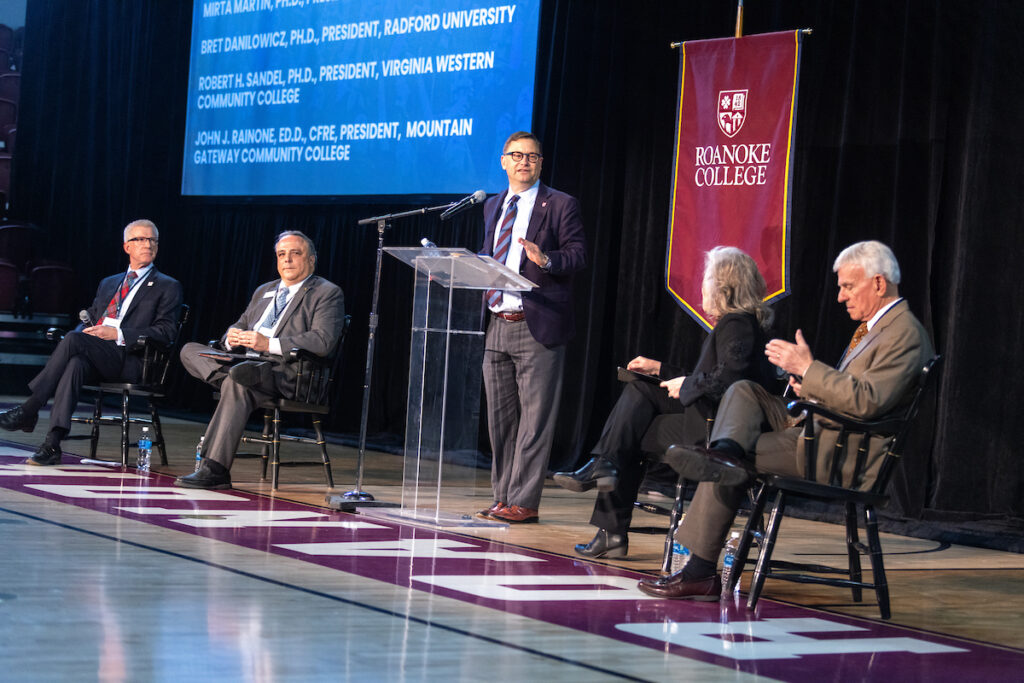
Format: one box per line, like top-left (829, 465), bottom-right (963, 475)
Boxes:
top-left (175, 230), bottom-right (345, 488)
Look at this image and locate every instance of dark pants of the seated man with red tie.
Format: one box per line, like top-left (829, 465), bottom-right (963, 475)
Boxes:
top-left (29, 332), bottom-right (130, 430)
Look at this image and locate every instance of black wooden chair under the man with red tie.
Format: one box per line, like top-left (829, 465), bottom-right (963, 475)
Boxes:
top-left (66, 304), bottom-right (189, 465)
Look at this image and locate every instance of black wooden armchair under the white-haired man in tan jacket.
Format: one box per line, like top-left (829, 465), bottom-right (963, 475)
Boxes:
top-left (722, 355), bottom-right (942, 618)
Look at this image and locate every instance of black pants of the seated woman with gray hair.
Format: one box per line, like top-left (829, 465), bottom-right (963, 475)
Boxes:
top-left (590, 381), bottom-right (706, 533)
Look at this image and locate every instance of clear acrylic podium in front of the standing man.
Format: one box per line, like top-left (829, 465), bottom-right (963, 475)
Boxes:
top-left (375, 247), bottom-right (537, 526)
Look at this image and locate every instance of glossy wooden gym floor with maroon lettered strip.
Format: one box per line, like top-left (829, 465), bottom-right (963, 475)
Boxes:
top-left (0, 397), bottom-right (1024, 681)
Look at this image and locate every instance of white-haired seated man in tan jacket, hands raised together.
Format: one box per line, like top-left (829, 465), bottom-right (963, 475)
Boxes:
top-left (640, 242), bottom-right (934, 600)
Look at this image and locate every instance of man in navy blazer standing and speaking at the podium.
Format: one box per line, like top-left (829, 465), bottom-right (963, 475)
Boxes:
top-left (477, 131), bottom-right (587, 523)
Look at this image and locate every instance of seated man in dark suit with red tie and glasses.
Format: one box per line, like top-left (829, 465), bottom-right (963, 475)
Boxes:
top-left (0, 220), bottom-right (182, 465)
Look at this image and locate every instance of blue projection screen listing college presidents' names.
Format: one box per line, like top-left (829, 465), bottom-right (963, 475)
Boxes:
top-left (181, 0), bottom-right (540, 196)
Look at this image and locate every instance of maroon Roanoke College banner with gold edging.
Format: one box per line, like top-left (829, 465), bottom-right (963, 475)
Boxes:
top-left (666, 31), bottom-right (802, 330)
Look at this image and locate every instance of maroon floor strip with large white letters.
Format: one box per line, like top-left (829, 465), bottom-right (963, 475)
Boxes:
top-left (0, 443), bottom-right (1024, 681)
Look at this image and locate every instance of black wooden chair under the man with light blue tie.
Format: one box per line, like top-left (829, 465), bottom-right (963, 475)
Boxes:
top-left (220, 315), bottom-right (352, 490)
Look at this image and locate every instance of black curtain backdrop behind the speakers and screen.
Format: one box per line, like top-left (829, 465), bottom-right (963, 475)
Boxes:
top-left (11, 0), bottom-right (1024, 538)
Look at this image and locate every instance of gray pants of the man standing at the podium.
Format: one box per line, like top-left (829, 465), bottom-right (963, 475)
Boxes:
top-left (483, 316), bottom-right (565, 509)
